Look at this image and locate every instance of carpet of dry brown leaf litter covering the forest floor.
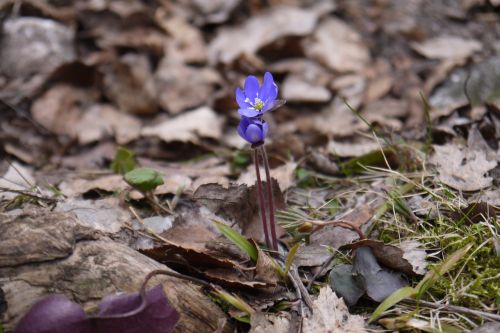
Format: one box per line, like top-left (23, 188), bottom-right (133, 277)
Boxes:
top-left (0, 0), bottom-right (500, 332)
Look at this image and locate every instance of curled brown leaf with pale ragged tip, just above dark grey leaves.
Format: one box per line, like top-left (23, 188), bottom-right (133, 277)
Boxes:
top-left (339, 239), bottom-right (427, 275)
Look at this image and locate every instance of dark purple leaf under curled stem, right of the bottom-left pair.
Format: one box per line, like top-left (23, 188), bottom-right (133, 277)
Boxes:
top-left (94, 285), bottom-right (179, 333)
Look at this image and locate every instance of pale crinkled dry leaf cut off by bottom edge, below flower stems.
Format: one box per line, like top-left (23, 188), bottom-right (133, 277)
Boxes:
top-left (302, 286), bottom-right (366, 333)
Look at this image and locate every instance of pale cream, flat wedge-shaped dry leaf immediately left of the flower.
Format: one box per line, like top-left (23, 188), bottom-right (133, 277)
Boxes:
top-left (141, 106), bottom-right (223, 143)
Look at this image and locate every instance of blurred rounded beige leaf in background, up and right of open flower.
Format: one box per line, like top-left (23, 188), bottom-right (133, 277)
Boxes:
top-left (305, 18), bottom-right (370, 73)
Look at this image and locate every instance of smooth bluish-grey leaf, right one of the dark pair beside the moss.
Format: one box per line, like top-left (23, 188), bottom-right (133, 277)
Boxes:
top-left (353, 246), bottom-right (408, 302)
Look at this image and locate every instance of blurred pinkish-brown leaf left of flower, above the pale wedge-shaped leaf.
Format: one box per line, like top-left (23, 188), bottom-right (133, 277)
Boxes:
top-left (155, 57), bottom-right (221, 114)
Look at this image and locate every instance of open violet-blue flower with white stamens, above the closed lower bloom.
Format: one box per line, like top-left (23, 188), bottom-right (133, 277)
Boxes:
top-left (236, 72), bottom-right (278, 118)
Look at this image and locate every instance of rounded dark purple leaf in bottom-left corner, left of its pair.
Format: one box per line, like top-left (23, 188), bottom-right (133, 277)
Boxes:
top-left (14, 294), bottom-right (91, 333)
